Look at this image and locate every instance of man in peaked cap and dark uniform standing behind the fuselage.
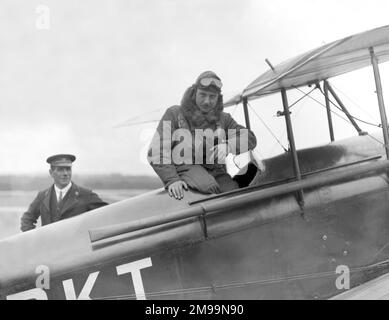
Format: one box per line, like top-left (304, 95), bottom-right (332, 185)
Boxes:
top-left (21, 154), bottom-right (107, 232)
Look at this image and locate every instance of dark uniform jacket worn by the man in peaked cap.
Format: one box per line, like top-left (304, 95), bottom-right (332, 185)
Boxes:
top-left (20, 182), bottom-right (107, 232)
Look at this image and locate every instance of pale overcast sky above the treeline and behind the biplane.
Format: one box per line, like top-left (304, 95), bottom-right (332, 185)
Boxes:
top-left (0, 0), bottom-right (389, 174)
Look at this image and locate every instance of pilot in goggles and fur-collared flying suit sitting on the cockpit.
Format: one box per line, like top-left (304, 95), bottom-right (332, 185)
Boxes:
top-left (148, 71), bottom-right (257, 199)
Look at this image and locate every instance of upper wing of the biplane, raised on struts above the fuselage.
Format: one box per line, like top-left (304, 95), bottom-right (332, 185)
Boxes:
top-left (225, 26), bottom-right (389, 106)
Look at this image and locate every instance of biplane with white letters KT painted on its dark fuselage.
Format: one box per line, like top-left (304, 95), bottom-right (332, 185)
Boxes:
top-left (0, 26), bottom-right (389, 300)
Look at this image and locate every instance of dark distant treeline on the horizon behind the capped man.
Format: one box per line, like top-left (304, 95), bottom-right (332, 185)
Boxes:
top-left (0, 174), bottom-right (162, 190)
